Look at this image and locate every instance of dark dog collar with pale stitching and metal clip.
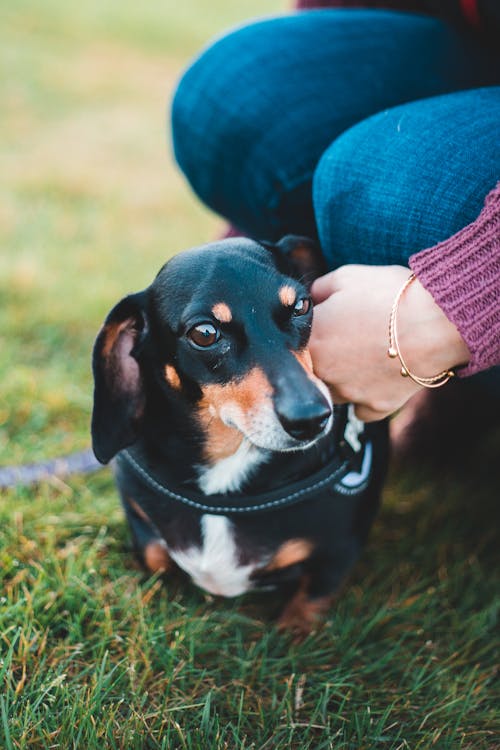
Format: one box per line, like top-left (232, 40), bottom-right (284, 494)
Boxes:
top-left (116, 405), bottom-right (372, 515)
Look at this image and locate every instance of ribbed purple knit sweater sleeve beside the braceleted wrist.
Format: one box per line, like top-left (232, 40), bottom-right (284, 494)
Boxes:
top-left (409, 182), bottom-right (500, 377)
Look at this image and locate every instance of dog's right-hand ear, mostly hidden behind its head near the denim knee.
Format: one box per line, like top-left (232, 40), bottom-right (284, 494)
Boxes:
top-left (261, 234), bottom-right (327, 287)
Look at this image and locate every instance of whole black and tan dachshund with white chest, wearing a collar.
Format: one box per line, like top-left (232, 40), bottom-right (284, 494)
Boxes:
top-left (92, 236), bottom-right (387, 634)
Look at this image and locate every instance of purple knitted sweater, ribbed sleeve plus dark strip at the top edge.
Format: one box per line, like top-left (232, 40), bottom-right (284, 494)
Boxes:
top-left (296, 0), bottom-right (500, 377)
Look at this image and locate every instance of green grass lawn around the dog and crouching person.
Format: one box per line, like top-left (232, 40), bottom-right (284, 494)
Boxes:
top-left (0, 0), bottom-right (500, 750)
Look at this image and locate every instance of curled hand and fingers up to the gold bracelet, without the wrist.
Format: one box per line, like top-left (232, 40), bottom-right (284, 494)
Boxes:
top-left (309, 265), bottom-right (416, 422)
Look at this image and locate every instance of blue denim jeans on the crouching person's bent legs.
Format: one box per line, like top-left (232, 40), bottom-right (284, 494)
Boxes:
top-left (172, 9), bottom-right (500, 388)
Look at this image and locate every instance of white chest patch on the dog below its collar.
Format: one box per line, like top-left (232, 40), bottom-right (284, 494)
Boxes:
top-left (169, 514), bottom-right (262, 596)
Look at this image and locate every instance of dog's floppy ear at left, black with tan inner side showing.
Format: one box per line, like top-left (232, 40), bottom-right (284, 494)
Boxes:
top-left (92, 292), bottom-right (148, 464)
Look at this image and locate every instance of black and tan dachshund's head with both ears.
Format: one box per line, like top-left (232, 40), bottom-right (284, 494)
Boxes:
top-left (92, 237), bottom-right (332, 470)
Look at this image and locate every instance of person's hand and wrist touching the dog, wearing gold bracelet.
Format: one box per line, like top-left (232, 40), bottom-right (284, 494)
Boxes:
top-left (310, 265), bottom-right (470, 422)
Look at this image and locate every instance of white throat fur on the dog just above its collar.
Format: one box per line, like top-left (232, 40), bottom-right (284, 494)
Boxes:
top-left (198, 438), bottom-right (266, 495)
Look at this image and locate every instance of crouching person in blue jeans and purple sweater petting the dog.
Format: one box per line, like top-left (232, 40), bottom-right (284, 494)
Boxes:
top-left (172, 0), bottom-right (500, 440)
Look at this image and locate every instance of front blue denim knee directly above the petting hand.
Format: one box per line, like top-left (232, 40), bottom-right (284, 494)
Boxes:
top-left (313, 88), bottom-right (500, 267)
